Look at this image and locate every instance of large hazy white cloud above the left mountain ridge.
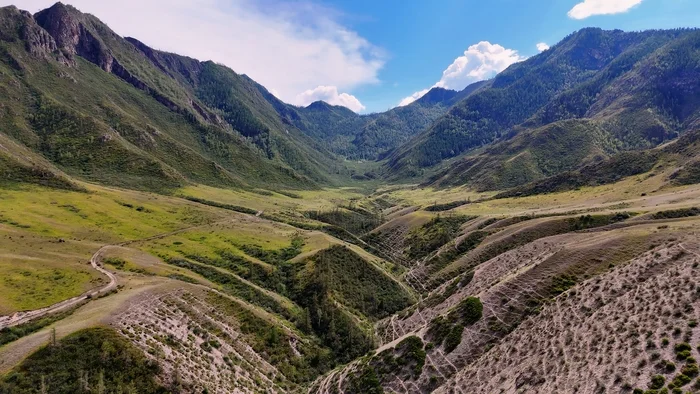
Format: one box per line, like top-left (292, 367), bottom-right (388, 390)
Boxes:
top-left (9, 0), bottom-right (384, 104)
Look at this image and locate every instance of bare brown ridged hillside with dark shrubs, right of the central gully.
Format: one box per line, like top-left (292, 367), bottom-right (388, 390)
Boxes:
top-left (316, 220), bottom-right (700, 393)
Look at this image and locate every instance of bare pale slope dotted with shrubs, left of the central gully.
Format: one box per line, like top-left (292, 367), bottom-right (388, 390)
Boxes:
top-left (113, 289), bottom-right (292, 393)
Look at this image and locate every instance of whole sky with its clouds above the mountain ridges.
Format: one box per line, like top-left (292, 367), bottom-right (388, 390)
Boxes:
top-left (9, 0), bottom-right (700, 113)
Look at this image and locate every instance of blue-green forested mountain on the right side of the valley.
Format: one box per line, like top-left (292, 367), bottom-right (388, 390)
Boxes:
top-left (386, 29), bottom-right (700, 185)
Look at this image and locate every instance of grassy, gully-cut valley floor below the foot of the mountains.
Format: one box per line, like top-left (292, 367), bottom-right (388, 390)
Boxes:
top-left (0, 176), bottom-right (700, 393)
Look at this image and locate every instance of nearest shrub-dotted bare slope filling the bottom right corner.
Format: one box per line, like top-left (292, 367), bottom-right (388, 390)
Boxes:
top-left (437, 239), bottom-right (700, 393)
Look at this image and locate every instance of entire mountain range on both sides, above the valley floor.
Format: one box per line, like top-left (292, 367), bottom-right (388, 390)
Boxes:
top-left (0, 3), bottom-right (700, 197)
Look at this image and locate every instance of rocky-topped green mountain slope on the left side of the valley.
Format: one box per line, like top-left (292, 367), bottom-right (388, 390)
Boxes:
top-left (0, 3), bottom-right (343, 190)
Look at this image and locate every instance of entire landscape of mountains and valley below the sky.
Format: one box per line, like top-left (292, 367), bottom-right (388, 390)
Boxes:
top-left (0, 3), bottom-right (700, 394)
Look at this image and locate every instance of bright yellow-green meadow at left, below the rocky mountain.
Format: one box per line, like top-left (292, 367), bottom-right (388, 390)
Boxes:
top-left (0, 185), bottom-right (228, 313)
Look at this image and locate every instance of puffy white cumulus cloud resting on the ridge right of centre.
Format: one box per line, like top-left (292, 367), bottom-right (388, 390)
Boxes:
top-left (399, 41), bottom-right (525, 106)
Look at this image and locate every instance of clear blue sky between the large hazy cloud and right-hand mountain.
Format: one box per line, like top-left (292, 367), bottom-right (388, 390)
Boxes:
top-left (328, 0), bottom-right (700, 111)
